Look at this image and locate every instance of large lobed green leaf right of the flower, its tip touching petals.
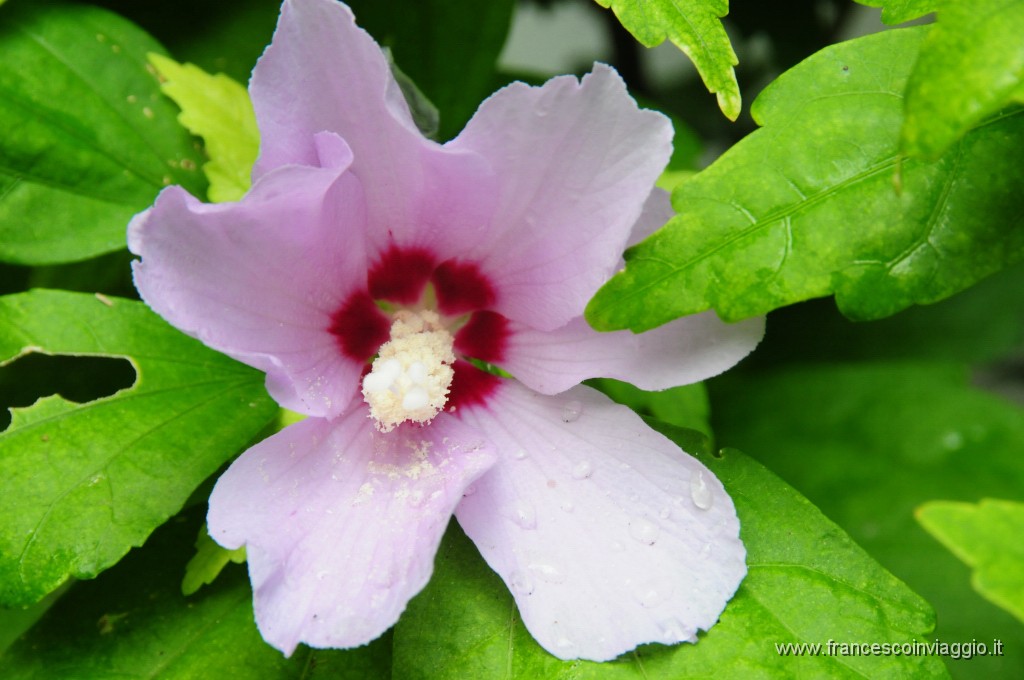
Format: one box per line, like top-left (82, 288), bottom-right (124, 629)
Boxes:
top-left (587, 27), bottom-right (1024, 331)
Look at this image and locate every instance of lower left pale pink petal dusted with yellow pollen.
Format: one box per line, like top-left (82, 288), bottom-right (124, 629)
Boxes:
top-left (207, 405), bottom-right (495, 654)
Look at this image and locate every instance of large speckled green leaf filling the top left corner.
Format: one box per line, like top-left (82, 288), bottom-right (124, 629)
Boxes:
top-left (0, 1), bottom-right (205, 264)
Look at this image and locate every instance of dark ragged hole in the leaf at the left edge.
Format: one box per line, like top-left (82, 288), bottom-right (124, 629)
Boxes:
top-left (0, 352), bottom-right (135, 431)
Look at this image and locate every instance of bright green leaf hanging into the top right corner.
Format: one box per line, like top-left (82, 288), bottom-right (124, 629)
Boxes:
top-left (902, 0), bottom-right (1024, 158)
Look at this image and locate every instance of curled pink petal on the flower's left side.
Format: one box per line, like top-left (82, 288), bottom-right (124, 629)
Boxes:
top-left (128, 142), bottom-right (367, 416)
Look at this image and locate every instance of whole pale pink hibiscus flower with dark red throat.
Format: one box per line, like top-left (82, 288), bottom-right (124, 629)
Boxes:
top-left (129, 0), bottom-right (763, 661)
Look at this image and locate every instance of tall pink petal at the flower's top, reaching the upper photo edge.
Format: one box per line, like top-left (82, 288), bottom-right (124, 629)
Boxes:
top-left (250, 0), bottom-right (495, 260)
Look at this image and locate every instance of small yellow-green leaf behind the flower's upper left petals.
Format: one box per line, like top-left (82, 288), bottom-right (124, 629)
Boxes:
top-left (150, 53), bottom-right (259, 203)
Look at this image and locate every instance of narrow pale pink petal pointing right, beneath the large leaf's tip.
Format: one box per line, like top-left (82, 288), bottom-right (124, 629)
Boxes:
top-left (502, 311), bottom-right (764, 394)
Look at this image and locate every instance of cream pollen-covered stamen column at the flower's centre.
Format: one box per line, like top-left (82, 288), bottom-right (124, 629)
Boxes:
top-left (362, 309), bottom-right (455, 432)
